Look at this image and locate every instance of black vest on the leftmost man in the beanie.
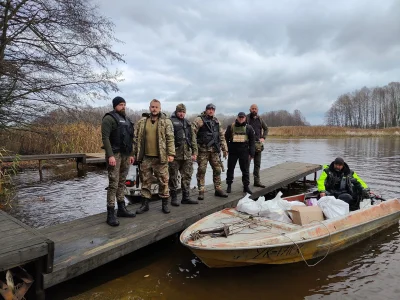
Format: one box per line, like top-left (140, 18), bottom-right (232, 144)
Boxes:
top-left (103, 110), bottom-right (134, 154)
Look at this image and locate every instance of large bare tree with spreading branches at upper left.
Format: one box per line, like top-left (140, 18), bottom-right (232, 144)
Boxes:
top-left (0, 0), bottom-right (123, 128)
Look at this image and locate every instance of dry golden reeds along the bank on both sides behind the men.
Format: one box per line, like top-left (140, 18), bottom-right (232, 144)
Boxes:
top-left (0, 123), bottom-right (400, 154)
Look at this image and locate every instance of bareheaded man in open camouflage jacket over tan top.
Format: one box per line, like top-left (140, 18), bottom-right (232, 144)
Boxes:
top-left (133, 99), bottom-right (175, 214)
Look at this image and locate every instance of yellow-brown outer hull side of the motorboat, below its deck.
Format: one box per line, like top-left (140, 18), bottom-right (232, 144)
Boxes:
top-left (182, 200), bottom-right (400, 268)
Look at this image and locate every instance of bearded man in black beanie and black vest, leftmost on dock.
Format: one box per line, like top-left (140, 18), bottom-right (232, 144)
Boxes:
top-left (101, 96), bottom-right (135, 226)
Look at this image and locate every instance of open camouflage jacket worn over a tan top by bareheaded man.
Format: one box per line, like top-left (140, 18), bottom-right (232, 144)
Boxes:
top-left (133, 113), bottom-right (175, 163)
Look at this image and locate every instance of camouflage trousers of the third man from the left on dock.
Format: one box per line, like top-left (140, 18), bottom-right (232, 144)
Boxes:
top-left (168, 159), bottom-right (193, 191)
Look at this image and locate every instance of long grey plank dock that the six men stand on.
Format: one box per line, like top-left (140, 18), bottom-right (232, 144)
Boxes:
top-left (35, 162), bottom-right (322, 289)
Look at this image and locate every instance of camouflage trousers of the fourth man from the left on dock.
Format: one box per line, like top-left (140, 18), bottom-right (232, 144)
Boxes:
top-left (196, 151), bottom-right (221, 191)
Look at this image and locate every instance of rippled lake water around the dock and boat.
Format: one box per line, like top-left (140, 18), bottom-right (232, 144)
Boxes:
top-left (5, 137), bottom-right (400, 299)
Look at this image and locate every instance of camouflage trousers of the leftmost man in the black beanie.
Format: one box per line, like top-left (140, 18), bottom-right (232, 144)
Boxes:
top-left (106, 153), bottom-right (129, 207)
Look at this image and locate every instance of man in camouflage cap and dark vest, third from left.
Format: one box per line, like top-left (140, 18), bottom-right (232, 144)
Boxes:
top-left (169, 103), bottom-right (198, 206)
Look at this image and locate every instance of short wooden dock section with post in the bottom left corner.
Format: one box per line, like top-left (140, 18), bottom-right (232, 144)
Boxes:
top-left (0, 210), bottom-right (54, 299)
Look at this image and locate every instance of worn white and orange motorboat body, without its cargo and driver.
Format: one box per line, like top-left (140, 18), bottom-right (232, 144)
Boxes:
top-left (180, 194), bottom-right (400, 268)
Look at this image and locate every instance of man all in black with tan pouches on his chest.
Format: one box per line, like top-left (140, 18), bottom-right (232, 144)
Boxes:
top-left (225, 112), bottom-right (255, 194)
